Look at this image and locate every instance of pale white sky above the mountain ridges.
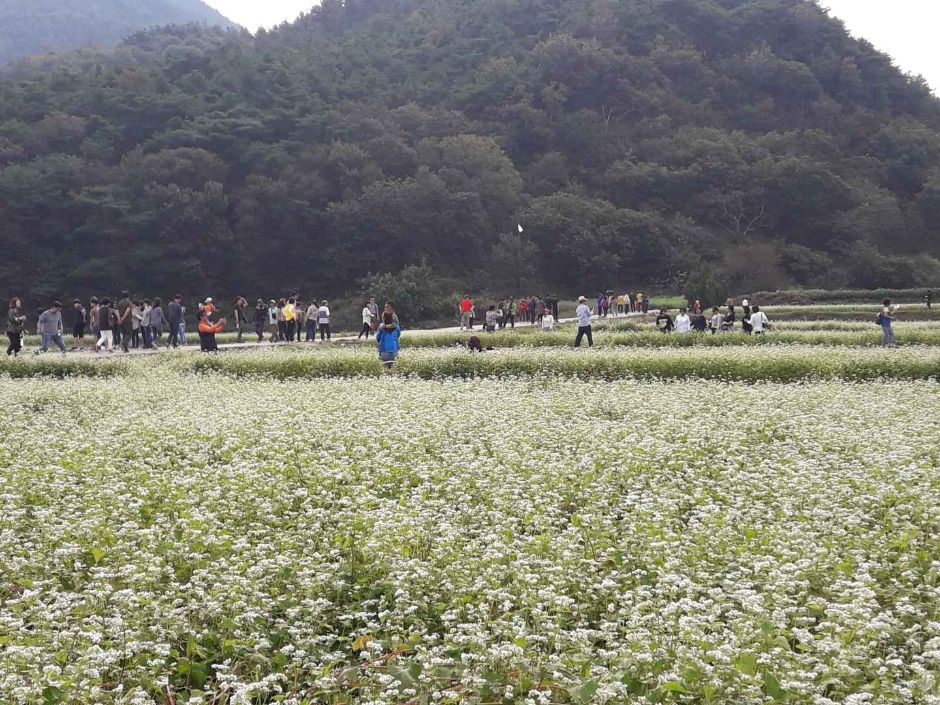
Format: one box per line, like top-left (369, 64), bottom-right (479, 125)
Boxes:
top-left (206, 0), bottom-right (940, 93)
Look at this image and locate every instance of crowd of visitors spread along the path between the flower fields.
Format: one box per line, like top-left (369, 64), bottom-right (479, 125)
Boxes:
top-left (1, 291), bottom-right (912, 360)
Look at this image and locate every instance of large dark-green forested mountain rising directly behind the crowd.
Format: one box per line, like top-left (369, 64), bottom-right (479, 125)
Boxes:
top-left (0, 0), bottom-right (940, 304)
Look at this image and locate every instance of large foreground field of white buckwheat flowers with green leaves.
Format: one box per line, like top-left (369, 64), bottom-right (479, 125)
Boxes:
top-left (0, 349), bottom-right (940, 705)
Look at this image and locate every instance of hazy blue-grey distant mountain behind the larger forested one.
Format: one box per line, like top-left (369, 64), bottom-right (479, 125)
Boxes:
top-left (0, 0), bottom-right (232, 63)
